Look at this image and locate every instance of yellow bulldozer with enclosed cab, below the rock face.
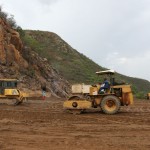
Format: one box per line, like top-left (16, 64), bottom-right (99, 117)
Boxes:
top-left (0, 79), bottom-right (27, 105)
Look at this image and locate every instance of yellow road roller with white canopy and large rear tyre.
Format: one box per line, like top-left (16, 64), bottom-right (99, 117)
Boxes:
top-left (63, 70), bottom-right (133, 115)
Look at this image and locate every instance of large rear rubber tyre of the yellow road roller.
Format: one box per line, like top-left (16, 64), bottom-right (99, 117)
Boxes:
top-left (100, 95), bottom-right (121, 115)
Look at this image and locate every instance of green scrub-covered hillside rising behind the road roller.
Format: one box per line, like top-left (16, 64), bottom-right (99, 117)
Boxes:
top-left (23, 30), bottom-right (150, 98)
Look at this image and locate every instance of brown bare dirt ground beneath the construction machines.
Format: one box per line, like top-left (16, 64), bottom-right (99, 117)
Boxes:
top-left (0, 98), bottom-right (150, 150)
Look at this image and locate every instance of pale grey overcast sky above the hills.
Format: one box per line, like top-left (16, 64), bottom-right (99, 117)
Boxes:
top-left (0, 0), bottom-right (150, 81)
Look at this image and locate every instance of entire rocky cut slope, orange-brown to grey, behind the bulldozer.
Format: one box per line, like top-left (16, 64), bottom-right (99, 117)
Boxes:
top-left (0, 18), bottom-right (70, 97)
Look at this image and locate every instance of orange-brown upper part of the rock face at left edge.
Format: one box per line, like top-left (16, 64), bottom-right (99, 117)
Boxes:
top-left (0, 19), bottom-right (28, 68)
